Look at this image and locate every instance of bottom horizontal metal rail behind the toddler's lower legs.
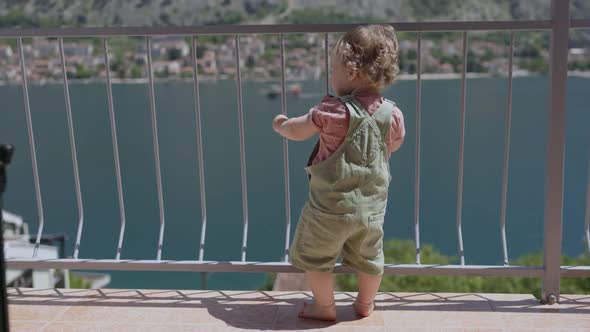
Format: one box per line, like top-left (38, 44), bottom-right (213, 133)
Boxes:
top-left (6, 258), bottom-right (544, 277)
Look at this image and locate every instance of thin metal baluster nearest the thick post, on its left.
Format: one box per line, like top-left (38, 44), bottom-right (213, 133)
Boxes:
top-left (500, 31), bottom-right (514, 265)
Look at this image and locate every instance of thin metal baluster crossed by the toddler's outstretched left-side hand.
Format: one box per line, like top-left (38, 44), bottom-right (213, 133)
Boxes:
top-left (281, 33), bottom-right (291, 262)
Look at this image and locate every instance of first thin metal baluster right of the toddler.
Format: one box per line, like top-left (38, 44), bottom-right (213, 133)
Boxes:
top-left (414, 32), bottom-right (422, 264)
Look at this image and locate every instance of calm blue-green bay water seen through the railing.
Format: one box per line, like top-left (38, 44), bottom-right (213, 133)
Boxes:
top-left (0, 77), bottom-right (590, 289)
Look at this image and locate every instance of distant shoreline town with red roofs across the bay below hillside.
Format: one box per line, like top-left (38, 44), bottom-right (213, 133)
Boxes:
top-left (0, 32), bottom-right (590, 83)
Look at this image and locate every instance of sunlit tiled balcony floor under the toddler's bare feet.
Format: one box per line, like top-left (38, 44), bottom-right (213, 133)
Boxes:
top-left (8, 288), bottom-right (590, 332)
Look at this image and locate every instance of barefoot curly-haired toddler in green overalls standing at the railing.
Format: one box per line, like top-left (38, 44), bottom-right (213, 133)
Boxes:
top-left (273, 25), bottom-right (405, 321)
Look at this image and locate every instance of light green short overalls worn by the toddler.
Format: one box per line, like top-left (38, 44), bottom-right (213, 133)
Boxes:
top-left (289, 96), bottom-right (395, 275)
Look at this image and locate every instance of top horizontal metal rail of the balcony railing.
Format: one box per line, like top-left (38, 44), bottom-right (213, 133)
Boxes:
top-left (0, 20), bottom-right (556, 38)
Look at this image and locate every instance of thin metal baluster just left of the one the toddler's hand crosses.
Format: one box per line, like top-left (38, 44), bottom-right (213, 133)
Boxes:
top-left (234, 35), bottom-right (248, 262)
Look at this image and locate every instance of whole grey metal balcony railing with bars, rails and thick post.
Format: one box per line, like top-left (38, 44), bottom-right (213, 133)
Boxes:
top-left (0, 0), bottom-right (590, 303)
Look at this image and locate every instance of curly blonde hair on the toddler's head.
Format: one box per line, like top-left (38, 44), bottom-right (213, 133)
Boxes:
top-left (332, 25), bottom-right (399, 88)
